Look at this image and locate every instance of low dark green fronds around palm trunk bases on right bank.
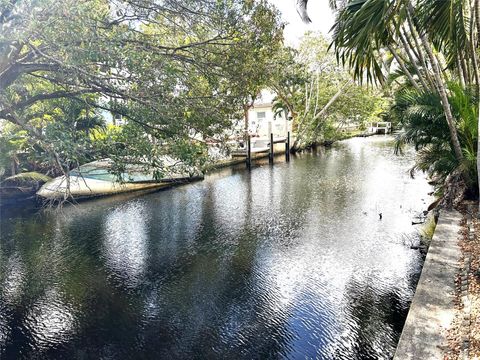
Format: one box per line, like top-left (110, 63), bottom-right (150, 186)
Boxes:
top-left (392, 82), bottom-right (478, 188)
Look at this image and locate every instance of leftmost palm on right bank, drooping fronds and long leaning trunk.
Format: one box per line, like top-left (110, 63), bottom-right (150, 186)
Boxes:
top-left (332, 0), bottom-right (472, 162)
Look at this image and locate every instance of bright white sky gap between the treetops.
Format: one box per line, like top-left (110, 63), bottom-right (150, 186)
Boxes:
top-left (269, 0), bottom-right (334, 47)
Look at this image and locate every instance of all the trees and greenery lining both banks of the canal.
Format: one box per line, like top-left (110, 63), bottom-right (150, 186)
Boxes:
top-left (0, 0), bottom-right (480, 208)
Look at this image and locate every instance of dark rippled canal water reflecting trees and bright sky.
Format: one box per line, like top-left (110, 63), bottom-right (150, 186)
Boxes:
top-left (0, 136), bottom-right (430, 360)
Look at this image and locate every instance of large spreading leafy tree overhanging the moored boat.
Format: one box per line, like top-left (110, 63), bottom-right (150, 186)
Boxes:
top-left (0, 0), bottom-right (281, 176)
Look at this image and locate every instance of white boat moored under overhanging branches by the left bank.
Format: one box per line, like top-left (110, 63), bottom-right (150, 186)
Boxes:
top-left (37, 158), bottom-right (203, 199)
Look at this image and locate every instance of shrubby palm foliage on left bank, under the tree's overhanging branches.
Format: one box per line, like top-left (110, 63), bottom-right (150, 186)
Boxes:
top-left (0, 98), bottom-right (109, 175)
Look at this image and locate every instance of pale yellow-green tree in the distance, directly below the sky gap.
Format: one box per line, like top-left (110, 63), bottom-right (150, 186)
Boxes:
top-left (273, 33), bottom-right (387, 146)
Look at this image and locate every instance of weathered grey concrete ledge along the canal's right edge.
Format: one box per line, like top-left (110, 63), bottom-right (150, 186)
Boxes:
top-left (394, 211), bottom-right (462, 360)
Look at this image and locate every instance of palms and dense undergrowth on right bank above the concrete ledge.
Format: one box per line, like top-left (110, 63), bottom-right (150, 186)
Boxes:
top-left (332, 0), bottom-right (480, 205)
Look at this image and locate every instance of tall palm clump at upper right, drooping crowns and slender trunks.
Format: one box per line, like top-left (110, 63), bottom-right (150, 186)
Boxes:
top-left (326, 0), bottom-right (480, 205)
